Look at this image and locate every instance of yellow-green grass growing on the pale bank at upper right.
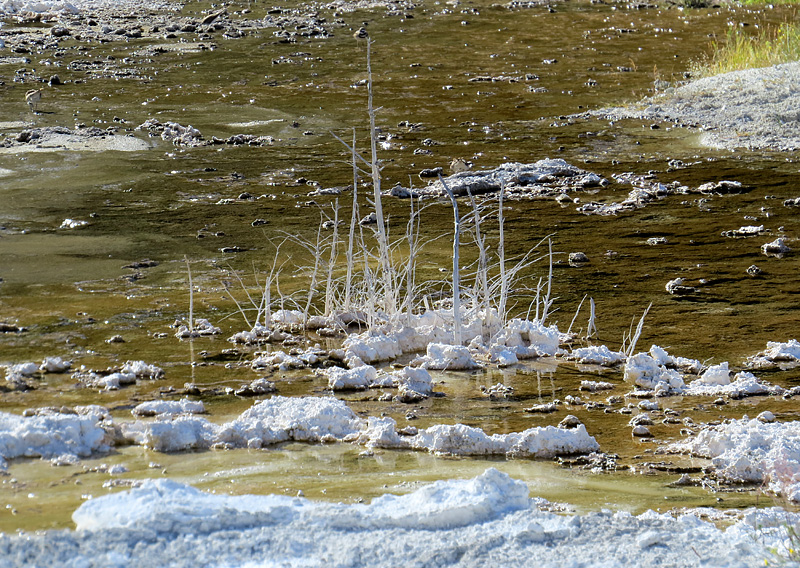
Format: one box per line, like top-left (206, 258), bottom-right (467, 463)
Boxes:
top-left (692, 23), bottom-right (800, 77)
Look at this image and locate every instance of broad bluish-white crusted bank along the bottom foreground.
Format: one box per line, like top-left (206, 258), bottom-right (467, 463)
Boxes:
top-left (0, 469), bottom-right (798, 568)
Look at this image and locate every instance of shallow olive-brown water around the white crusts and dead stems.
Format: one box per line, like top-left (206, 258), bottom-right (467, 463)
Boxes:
top-left (0, 2), bottom-right (800, 531)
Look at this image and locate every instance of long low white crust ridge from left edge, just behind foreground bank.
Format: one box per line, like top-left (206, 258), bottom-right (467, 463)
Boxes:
top-left (0, 394), bottom-right (598, 463)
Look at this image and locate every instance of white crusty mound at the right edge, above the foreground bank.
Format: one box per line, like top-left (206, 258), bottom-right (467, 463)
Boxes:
top-left (671, 418), bottom-right (800, 502)
